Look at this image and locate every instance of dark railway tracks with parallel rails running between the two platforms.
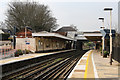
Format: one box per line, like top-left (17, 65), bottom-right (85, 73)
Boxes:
top-left (2, 51), bottom-right (85, 80)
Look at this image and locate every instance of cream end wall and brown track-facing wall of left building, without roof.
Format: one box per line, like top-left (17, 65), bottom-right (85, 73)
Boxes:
top-left (16, 37), bottom-right (66, 51)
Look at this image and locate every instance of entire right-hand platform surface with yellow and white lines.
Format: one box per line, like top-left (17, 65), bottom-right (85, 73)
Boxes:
top-left (67, 50), bottom-right (120, 80)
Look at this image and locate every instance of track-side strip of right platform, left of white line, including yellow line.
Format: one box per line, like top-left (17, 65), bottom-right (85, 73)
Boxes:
top-left (68, 51), bottom-right (94, 80)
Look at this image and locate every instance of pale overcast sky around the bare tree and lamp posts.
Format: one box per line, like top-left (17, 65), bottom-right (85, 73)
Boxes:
top-left (0, 0), bottom-right (118, 31)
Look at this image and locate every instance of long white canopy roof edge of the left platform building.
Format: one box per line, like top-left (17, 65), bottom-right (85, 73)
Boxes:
top-left (32, 32), bottom-right (74, 40)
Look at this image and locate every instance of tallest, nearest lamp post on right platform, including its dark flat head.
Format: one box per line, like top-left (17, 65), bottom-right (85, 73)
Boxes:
top-left (104, 8), bottom-right (113, 65)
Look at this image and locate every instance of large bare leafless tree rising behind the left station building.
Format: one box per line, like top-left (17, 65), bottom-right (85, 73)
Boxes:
top-left (6, 2), bottom-right (58, 32)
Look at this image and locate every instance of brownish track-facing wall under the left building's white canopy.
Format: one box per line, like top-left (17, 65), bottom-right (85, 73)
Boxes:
top-left (35, 37), bottom-right (65, 51)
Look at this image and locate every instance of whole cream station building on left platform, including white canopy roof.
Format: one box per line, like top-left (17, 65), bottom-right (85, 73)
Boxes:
top-left (16, 31), bottom-right (74, 52)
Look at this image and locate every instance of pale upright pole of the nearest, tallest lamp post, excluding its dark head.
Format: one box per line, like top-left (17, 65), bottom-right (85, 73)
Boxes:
top-left (110, 10), bottom-right (112, 65)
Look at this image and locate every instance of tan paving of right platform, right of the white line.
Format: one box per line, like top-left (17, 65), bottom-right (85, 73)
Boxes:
top-left (93, 50), bottom-right (120, 79)
